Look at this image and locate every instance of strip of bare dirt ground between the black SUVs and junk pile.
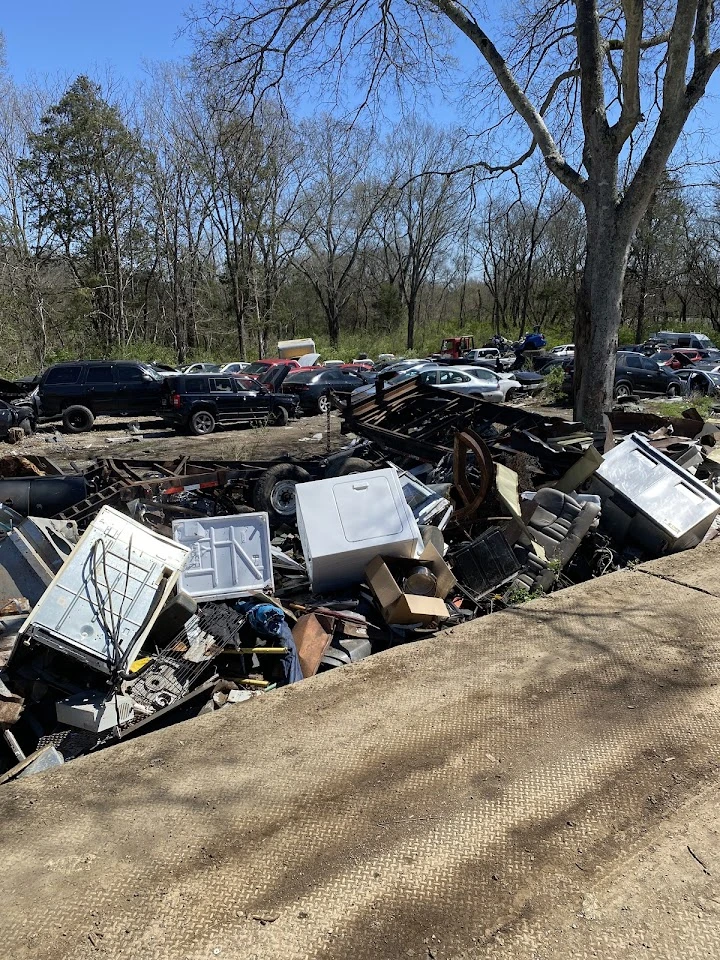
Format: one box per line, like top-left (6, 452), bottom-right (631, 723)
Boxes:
top-left (13, 412), bottom-right (348, 463)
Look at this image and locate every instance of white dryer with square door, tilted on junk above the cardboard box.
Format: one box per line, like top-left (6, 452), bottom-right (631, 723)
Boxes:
top-left (295, 467), bottom-right (423, 593)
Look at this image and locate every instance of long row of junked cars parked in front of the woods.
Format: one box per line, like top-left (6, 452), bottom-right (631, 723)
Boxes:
top-left (7, 331), bottom-right (720, 436)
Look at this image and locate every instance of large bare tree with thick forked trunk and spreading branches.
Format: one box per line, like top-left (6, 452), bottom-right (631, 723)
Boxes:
top-left (196, 0), bottom-right (720, 428)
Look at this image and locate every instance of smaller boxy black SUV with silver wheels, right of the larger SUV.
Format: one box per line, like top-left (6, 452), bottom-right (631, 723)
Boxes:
top-left (161, 373), bottom-right (297, 437)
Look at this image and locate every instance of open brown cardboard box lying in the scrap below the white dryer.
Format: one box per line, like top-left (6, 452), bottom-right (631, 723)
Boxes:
top-left (365, 544), bottom-right (457, 623)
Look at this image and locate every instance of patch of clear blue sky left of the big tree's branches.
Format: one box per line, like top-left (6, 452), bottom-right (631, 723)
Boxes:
top-left (0, 0), bottom-right (189, 82)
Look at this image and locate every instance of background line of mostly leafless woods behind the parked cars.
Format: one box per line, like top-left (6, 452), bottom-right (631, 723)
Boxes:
top-left (0, 66), bottom-right (720, 369)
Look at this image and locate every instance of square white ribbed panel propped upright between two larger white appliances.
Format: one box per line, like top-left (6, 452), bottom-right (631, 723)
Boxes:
top-left (173, 513), bottom-right (275, 601)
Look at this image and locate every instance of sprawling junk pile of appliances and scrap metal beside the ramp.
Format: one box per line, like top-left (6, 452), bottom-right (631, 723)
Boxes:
top-left (0, 379), bottom-right (720, 784)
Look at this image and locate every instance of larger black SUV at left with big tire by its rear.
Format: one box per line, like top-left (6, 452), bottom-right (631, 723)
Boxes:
top-left (38, 360), bottom-right (163, 433)
